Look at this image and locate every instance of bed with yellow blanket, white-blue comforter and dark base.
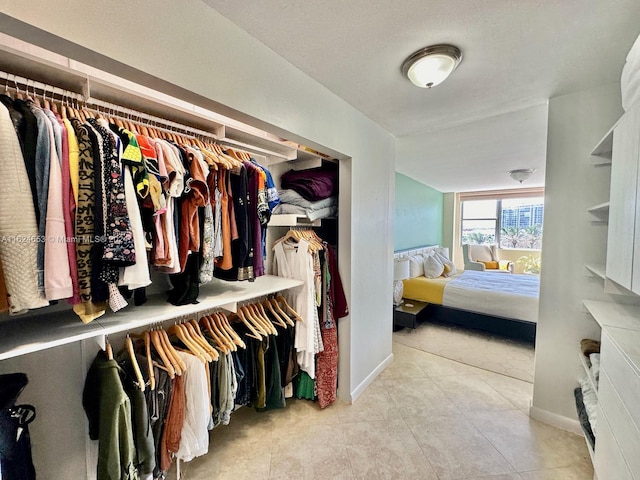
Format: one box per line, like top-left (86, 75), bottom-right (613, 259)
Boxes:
top-left (394, 246), bottom-right (540, 342)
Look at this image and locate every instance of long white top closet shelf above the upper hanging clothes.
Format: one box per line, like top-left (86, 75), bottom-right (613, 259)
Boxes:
top-left (0, 32), bottom-right (329, 164)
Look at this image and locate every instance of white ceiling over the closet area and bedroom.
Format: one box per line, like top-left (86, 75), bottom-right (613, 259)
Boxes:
top-left (204, 0), bottom-right (640, 192)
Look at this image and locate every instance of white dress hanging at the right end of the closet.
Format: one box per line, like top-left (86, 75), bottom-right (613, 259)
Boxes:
top-left (273, 240), bottom-right (324, 378)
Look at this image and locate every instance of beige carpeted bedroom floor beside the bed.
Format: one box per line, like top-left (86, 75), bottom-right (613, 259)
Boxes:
top-left (393, 322), bottom-right (534, 383)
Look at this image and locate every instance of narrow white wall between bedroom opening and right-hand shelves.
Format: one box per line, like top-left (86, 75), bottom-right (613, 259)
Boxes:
top-left (531, 84), bottom-right (622, 428)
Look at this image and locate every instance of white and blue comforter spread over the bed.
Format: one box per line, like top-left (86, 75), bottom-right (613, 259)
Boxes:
top-left (442, 270), bottom-right (540, 323)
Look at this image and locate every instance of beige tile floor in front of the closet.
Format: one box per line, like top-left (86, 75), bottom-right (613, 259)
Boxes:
top-left (176, 343), bottom-right (593, 480)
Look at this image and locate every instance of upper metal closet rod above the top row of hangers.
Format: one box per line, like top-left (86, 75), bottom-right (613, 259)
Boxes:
top-left (0, 70), bottom-right (220, 141)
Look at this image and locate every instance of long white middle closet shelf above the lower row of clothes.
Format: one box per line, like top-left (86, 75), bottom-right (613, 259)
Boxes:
top-left (0, 275), bottom-right (303, 360)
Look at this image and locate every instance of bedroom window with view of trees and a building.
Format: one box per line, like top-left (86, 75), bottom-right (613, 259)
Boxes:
top-left (460, 194), bottom-right (544, 250)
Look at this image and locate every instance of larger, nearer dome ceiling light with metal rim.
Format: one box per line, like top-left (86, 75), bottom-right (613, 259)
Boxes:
top-left (402, 45), bottom-right (462, 88)
